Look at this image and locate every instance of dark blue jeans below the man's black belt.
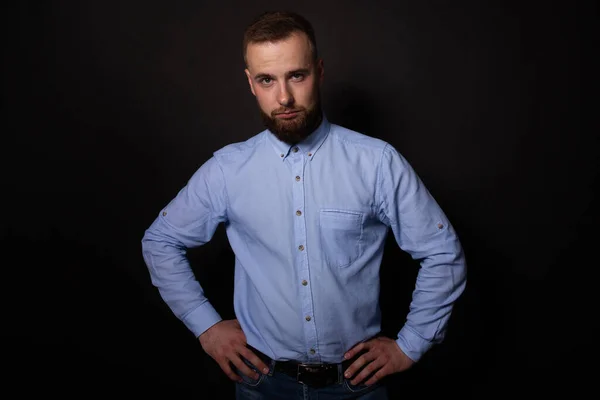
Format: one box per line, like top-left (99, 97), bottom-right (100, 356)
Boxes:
top-left (235, 362), bottom-right (388, 400)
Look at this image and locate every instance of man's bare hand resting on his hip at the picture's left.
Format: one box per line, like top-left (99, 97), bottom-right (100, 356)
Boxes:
top-left (198, 319), bottom-right (269, 382)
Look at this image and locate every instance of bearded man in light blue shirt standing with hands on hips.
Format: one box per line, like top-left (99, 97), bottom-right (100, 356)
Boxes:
top-left (142, 12), bottom-right (466, 399)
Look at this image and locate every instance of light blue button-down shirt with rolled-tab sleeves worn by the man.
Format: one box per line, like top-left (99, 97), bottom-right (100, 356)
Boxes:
top-left (142, 118), bottom-right (466, 362)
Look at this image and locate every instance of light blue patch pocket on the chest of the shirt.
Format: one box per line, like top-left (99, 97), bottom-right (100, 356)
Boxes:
top-left (319, 209), bottom-right (363, 268)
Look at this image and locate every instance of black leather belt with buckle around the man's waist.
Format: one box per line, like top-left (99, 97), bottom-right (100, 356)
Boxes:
top-left (248, 345), bottom-right (362, 387)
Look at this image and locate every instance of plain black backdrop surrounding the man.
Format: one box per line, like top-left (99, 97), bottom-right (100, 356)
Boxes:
top-left (0, 0), bottom-right (600, 399)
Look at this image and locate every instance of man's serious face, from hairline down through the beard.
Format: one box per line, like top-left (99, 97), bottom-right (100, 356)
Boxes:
top-left (245, 32), bottom-right (324, 144)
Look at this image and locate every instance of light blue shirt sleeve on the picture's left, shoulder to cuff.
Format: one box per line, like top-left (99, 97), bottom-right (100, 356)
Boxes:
top-left (142, 157), bottom-right (227, 337)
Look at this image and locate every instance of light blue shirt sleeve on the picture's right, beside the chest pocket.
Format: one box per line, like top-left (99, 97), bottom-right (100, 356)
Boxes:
top-left (378, 144), bottom-right (466, 361)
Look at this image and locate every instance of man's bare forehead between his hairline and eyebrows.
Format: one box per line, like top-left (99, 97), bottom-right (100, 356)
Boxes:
top-left (246, 32), bottom-right (312, 74)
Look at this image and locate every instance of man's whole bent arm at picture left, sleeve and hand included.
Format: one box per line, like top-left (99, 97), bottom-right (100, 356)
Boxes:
top-left (142, 157), bottom-right (268, 381)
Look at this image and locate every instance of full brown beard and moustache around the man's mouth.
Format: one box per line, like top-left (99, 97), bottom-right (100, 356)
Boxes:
top-left (259, 95), bottom-right (323, 145)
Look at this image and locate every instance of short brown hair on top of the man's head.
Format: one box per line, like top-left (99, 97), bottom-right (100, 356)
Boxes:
top-left (243, 11), bottom-right (318, 64)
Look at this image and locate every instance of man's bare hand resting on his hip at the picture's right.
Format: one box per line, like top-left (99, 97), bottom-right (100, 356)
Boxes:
top-left (344, 337), bottom-right (414, 386)
